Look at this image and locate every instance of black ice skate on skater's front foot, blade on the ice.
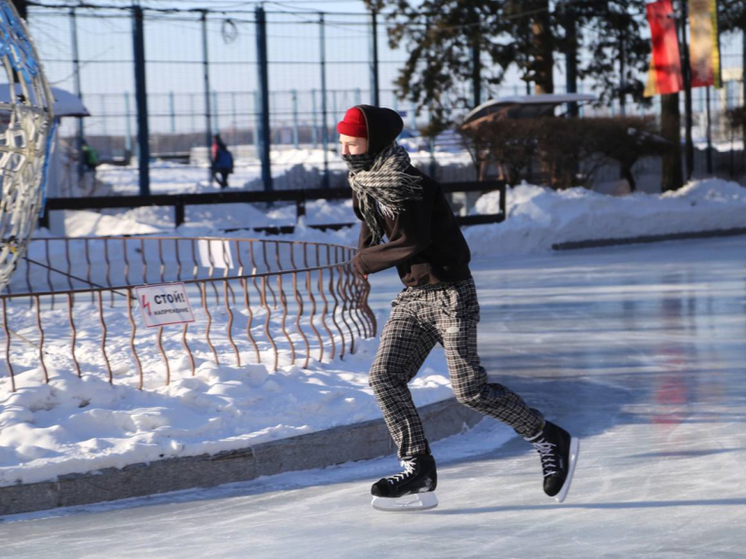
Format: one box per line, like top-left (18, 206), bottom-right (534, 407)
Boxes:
top-left (370, 454), bottom-right (438, 511)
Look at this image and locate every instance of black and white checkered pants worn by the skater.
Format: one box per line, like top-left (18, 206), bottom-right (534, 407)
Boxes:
top-left (370, 278), bottom-right (544, 458)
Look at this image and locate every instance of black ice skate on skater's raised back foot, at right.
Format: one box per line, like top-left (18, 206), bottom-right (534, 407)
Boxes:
top-left (526, 421), bottom-right (580, 503)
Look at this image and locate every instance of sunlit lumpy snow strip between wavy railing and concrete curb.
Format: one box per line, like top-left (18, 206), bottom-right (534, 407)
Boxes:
top-left (0, 328), bottom-right (452, 485)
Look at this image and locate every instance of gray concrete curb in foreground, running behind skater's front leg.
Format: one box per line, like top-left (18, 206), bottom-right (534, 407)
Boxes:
top-left (0, 398), bottom-right (484, 516)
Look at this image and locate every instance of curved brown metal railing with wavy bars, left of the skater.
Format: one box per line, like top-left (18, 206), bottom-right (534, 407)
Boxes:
top-left (0, 237), bottom-right (376, 391)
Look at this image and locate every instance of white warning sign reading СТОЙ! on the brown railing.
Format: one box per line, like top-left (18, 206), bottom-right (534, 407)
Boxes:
top-left (135, 282), bottom-right (194, 328)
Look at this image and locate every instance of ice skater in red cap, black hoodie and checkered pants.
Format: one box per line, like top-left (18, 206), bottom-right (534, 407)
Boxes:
top-left (337, 105), bottom-right (579, 509)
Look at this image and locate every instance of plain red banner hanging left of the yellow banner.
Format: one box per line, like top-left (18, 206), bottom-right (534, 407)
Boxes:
top-left (645, 0), bottom-right (684, 96)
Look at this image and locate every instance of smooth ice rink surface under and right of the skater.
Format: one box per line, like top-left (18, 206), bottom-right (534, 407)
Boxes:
top-left (0, 237), bottom-right (746, 559)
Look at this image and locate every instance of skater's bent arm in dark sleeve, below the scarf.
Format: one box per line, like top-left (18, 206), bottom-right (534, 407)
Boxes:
top-left (352, 195), bottom-right (433, 275)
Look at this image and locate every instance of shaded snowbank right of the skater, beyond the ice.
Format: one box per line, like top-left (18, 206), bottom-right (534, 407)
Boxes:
top-left (464, 179), bottom-right (746, 256)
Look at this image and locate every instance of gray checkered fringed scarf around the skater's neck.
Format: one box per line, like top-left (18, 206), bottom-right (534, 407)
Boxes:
top-left (349, 143), bottom-right (422, 245)
